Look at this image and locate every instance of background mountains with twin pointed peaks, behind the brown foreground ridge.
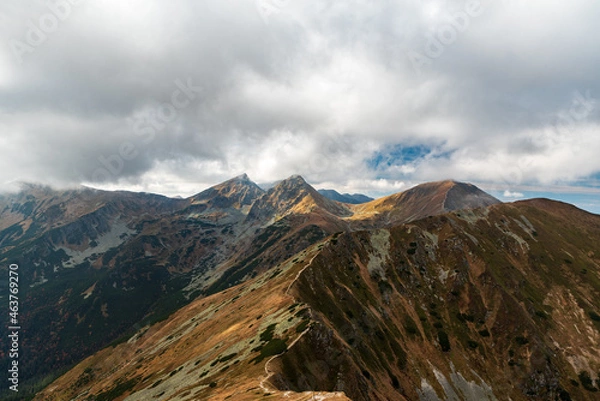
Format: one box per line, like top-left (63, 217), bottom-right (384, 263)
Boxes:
top-left (0, 175), bottom-right (506, 396)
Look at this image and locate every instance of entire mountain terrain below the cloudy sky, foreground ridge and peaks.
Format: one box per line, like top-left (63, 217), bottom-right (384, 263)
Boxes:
top-left (0, 175), bottom-right (600, 401)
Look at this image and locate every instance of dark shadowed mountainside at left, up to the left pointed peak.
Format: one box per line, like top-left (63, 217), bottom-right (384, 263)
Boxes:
top-left (0, 177), bottom-right (263, 394)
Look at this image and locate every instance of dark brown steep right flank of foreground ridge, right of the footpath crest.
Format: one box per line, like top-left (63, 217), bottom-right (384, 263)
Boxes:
top-left (278, 200), bottom-right (600, 400)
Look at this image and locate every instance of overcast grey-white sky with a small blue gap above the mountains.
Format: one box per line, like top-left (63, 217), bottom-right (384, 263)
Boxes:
top-left (0, 0), bottom-right (600, 212)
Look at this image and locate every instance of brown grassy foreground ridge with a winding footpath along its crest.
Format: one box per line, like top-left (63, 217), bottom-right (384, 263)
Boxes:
top-left (36, 200), bottom-right (600, 401)
